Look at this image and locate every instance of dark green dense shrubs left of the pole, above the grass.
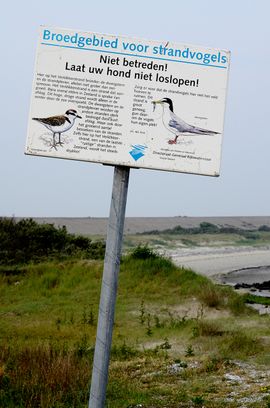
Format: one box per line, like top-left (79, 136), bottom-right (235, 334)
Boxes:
top-left (0, 218), bottom-right (105, 266)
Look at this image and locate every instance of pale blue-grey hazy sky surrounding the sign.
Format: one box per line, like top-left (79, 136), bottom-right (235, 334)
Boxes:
top-left (0, 0), bottom-right (270, 217)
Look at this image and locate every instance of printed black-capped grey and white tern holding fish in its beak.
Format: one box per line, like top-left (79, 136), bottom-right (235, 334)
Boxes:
top-left (152, 98), bottom-right (219, 144)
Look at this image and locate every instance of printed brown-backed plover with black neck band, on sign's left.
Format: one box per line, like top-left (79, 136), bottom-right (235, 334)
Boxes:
top-left (32, 109), bottom-right (82, 150)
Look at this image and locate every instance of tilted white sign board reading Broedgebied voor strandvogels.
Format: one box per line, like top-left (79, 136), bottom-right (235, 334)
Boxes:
top-left (26, 27), bottom-right (230, 176)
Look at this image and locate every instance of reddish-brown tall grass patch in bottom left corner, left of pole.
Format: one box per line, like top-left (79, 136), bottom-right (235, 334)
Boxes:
top-left (0, 344), bottom-right (91, 407)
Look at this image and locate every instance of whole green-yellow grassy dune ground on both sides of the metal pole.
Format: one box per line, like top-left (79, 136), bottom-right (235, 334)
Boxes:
top-left (0, 247), bottom-right (270, 408)
